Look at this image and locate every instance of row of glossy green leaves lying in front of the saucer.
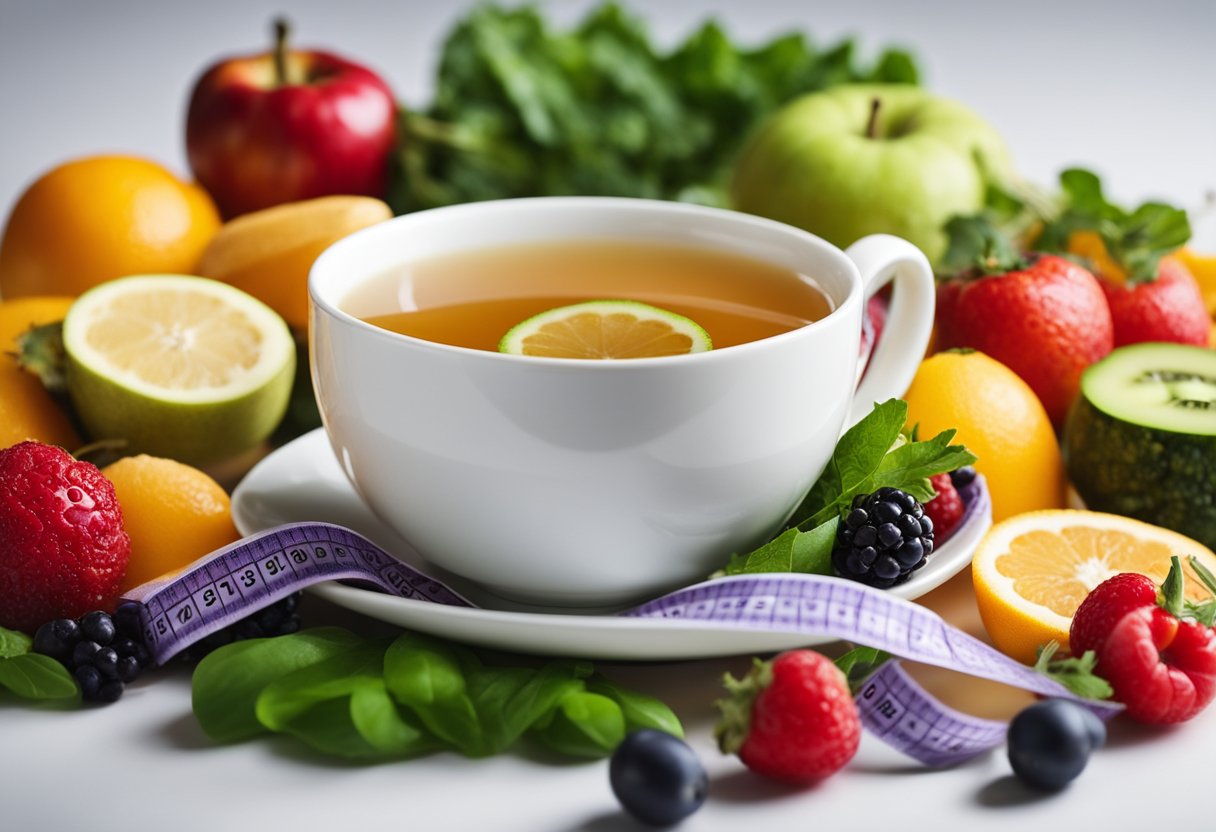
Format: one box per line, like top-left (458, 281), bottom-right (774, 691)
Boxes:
top-left (195, 629), bottom-right (682, 760)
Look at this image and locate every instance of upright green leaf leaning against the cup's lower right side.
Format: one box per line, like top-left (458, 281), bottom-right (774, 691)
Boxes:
top-left (788, 399), bottom-right (908, 528)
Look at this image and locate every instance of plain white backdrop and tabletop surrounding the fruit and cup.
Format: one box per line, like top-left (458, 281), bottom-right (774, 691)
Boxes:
top-left (0, 0), bottom-right (1216, 832)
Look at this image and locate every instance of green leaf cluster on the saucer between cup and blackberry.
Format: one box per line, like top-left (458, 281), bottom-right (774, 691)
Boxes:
top-left (722, 399), bottom-right (975, 575)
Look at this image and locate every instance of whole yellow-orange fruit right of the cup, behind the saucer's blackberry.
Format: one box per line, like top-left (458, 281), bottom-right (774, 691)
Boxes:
top-left (903, 352), bottom-right (1065, 522)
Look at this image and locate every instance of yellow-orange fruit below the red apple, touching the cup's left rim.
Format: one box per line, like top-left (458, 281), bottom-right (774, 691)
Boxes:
top-left (197, 196), bottom-right (393, 330)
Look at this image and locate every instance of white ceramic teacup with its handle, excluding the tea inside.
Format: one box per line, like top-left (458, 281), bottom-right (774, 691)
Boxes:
top-left (309, 197), bottom-right (934, 607)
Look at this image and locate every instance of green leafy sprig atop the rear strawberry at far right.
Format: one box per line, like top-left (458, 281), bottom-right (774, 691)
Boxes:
top-left (1035, 168), bottom-right (1190, 283)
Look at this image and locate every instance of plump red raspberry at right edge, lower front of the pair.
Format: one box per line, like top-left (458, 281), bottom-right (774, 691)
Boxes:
top-left (1096, 606), bottom-right (1216, 725)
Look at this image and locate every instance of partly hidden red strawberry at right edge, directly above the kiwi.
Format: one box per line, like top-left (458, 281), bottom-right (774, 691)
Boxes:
top-left (1098, 258), bottom-right (1212, 347)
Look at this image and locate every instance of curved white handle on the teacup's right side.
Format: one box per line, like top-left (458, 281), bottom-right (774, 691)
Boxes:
top-left (845, 234), bottom-right (936, 427)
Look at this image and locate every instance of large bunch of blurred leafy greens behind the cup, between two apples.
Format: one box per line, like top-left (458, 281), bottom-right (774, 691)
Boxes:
top-left (389, 2), bottom-right (918, 213)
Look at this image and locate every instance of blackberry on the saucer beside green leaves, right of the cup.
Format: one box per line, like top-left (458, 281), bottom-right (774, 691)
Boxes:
top-left (832, 488), bottom-right (933, 589)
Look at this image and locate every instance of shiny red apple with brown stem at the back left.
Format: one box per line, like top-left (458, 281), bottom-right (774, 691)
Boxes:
top-left (186, 21), bottom-right (396, 218)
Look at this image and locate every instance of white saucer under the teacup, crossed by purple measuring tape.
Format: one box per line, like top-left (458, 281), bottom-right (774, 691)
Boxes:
top-left (232, 429), bottom-right (992, 660)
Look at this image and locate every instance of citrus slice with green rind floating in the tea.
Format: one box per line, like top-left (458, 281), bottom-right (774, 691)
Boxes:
top-left (499, 300), bottom-right (713, 359)
